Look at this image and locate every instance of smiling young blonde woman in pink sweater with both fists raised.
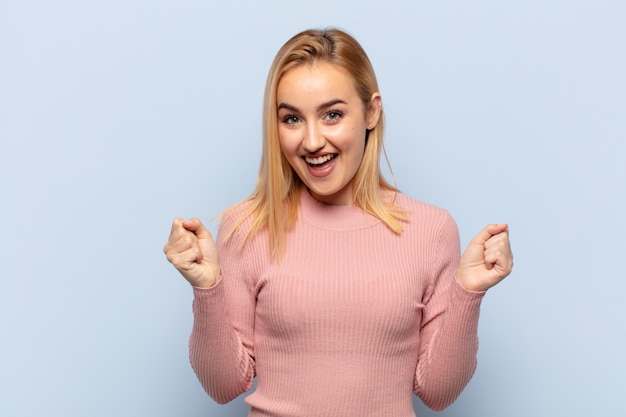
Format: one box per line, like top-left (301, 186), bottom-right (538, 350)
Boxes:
top-left (164, 30), bottom-right (513, 417)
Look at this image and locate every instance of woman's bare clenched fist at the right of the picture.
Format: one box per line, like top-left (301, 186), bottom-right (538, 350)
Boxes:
top-left (456, 224), bottom-right (513, 291)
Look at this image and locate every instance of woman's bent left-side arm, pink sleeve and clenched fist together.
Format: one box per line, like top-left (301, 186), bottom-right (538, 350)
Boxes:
top-left (165, 216), bottom-right (255, 404)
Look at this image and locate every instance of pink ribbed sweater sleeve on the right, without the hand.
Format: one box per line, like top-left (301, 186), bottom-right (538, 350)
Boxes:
top-left (414, 214), bottom-right (484, 410)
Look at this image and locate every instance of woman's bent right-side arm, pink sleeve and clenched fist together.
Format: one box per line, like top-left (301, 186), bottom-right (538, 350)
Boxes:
top-left (414, 217), bottom-right (513, 410)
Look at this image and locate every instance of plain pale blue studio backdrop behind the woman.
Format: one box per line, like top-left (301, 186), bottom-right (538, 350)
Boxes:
top-left (0, 0), bottom-right (626, 417)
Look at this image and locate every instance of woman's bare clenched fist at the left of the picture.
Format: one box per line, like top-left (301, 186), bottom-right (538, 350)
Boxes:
top-left (163, 217), bottom-right (220, 288)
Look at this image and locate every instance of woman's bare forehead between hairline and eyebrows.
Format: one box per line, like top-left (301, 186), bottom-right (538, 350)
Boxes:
top-left (276, 62), bottom-right (360, 103)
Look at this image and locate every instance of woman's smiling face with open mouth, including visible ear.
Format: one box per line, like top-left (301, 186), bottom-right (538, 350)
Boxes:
top-left (276, 62), bottom-right (380, 205)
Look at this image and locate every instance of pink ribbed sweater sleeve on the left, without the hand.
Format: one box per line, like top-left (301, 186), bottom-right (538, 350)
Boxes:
top-left (189, 211), bottom-right (256, 404)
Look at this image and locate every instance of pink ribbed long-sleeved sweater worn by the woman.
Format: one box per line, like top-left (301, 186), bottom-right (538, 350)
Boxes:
top-left (190, 192), bottom-right (483, 417)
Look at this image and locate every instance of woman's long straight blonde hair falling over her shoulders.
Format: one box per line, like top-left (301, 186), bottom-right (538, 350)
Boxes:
top-left (227, 29), bottom-right (406, 260)
